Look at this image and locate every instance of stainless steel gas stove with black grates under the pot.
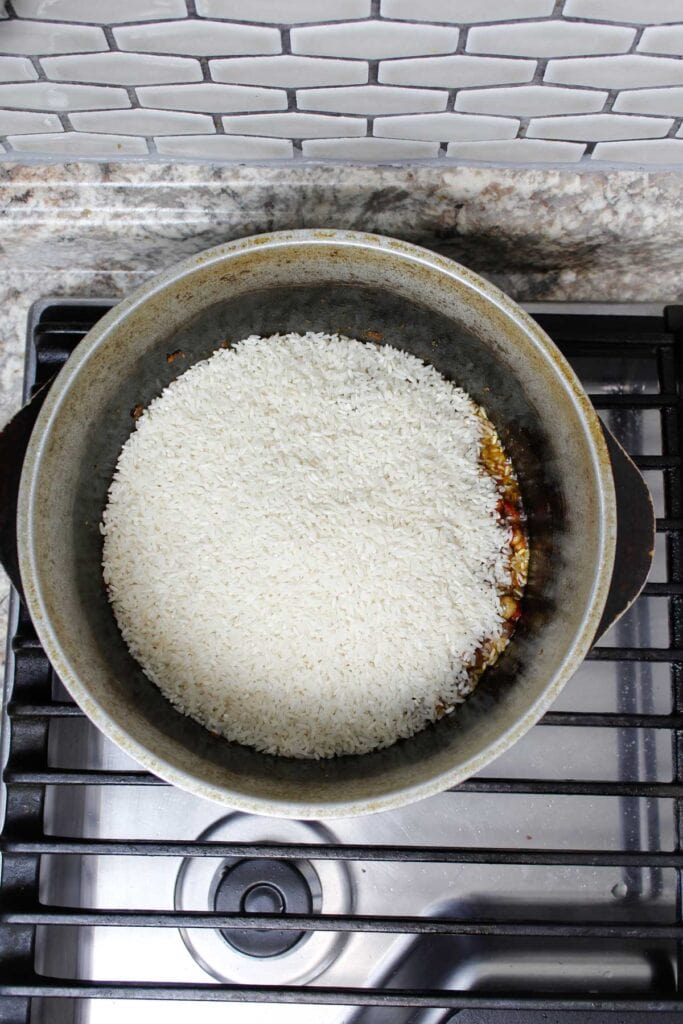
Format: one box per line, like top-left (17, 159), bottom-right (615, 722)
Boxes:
top-left (0, 299), bottom-right (683, 1024)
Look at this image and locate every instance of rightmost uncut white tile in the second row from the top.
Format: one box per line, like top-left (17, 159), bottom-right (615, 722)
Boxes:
top-left (467, 22), bottom-right (636, 57)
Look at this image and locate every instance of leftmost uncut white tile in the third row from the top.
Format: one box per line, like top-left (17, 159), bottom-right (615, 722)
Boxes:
top-left (41, 53), bottom-right (203, 85)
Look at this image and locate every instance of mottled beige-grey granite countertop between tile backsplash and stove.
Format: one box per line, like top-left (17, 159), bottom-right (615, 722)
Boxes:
top-left (0, 163), bottom-right (683, 655)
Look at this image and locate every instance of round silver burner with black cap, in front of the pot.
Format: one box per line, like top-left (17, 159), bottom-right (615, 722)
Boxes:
top-left (175, 813), bottom-right (353, 985)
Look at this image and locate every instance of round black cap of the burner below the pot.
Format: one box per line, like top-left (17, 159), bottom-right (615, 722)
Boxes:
top-left (214, 858), bottom-right (312, 956)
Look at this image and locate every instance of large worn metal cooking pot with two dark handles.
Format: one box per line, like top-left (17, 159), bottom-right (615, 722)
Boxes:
top-left (0, 230), bottom-right (653, 818)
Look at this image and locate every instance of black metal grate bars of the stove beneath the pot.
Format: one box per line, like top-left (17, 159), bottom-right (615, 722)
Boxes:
top-left (0, 300), bottom-right (683, 1024)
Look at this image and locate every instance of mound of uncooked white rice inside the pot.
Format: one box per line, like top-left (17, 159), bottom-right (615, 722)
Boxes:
top-left (101, 333), bottom-right (509, 758)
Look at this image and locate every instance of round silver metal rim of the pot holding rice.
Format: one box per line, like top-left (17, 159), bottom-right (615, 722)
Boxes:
top-left (17, 228), bottom-right (616, 819)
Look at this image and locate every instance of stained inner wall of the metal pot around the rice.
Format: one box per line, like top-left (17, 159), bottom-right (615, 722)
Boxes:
top-left (24, 241), bottom-right (600, 816)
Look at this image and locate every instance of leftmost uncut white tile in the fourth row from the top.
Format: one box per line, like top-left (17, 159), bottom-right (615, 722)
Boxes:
top-left (137, 82), bottom-right (287, 114)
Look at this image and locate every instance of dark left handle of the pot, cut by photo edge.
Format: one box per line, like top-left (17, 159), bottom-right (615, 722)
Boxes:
top-left (0, 381), bottom-right (51, 600)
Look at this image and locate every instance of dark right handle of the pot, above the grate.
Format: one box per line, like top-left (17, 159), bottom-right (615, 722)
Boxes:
top-left (594, 424), bottom-right (655, 643)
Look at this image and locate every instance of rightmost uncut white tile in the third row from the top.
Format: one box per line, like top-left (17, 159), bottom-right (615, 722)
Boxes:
top-left (379, 55), bottom-right (536, 89)
